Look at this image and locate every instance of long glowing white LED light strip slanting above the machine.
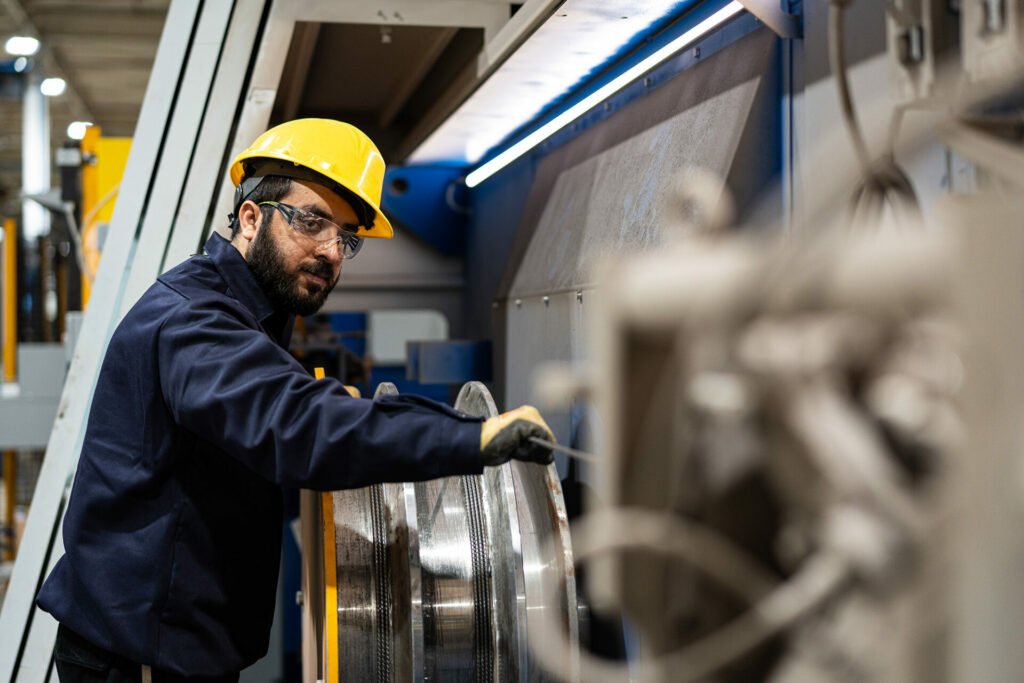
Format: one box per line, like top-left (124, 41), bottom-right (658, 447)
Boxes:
top-left (466, 0), bottom-right (743, 187)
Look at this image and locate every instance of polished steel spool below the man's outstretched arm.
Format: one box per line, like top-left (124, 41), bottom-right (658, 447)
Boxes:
top-left (322, 382), bottom-right (579, 683)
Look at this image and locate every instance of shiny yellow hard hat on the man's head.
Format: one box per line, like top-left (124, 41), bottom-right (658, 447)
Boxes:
top-left (230, 119), bottom-right (394, 238)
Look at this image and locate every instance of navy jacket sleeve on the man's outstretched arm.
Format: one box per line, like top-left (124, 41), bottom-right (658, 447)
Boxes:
top-left (156, 299), bottom-right (482, 490)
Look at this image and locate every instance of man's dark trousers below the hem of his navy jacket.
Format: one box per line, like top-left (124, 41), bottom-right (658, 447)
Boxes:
top-left (53, 624), bottom-right (239, 683)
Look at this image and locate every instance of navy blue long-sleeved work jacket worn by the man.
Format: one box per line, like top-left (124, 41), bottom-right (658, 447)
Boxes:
top-left (37, 234), bottom-right (482, 676)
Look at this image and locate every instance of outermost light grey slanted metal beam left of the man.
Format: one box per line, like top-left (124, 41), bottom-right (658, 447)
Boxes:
top-left (0, 0), bottom-right (220, 681)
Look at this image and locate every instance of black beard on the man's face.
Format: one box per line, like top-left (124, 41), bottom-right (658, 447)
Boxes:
top-left (246, 226), bottom-right (338, 315)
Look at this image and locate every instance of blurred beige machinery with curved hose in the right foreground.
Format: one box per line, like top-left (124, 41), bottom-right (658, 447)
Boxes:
top-left (536, 180), bottom-right (1024, 681)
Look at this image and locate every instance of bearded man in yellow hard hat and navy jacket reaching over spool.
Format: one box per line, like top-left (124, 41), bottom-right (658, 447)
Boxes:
top-left (37, 120), bottom-right (552, 683)
